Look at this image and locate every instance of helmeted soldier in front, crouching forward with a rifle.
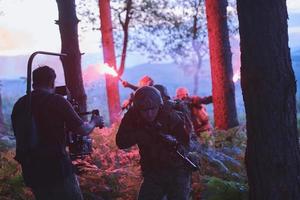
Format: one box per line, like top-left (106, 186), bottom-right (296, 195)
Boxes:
top-left (116, 86), bottom-right (191, 200)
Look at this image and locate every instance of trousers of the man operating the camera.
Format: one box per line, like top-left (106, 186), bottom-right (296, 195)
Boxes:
top-left (32, 174), bottom-right (83, 200)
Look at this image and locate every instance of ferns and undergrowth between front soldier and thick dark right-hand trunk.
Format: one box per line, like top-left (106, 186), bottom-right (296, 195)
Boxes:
top-left (188, 126), bottom-right (247, 200)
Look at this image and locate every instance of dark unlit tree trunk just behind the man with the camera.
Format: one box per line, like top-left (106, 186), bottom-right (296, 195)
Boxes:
top-left (56, 0), bottom-right (86, 112)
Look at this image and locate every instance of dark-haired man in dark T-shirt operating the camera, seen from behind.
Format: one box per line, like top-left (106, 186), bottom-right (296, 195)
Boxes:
top-left (11, 66), bottom-right (103, 200)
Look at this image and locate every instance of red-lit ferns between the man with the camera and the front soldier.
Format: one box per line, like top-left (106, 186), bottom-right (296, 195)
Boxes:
top-left (80, 124), bottom-right (141, 200)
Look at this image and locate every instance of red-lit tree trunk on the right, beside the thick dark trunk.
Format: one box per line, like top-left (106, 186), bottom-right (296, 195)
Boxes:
top-left (206, 0), bottom-right (238, 130)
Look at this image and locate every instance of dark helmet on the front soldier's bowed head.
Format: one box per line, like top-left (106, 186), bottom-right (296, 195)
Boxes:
top-left (133, 86), bottom-right (163, 110)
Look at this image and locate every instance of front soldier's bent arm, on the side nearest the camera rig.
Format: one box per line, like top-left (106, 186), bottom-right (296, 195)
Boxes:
top-left (116, 110), bottom-right (138, 149)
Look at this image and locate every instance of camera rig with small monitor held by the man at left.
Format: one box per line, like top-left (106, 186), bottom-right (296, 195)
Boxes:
top-left (55, 86), bottom-right (102, 160)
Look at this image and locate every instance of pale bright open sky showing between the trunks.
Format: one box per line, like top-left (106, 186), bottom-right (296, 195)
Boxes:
top-left (0, 0), bottom-right (300, 55)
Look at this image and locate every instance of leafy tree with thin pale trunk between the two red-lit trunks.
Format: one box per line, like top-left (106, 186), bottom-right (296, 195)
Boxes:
top-left (116, 0), bottom-right (207, 94)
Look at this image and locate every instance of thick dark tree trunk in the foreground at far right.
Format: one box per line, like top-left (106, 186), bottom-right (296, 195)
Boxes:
top-left (237, 0), bottom-right (300, 200)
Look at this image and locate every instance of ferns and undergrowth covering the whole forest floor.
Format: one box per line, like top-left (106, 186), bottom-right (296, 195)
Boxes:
top-left (0, 124), bottom-right (248, 200)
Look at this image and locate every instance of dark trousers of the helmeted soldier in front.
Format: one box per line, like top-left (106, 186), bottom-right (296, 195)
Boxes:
top-left (138, 170), bottom-right (191, 200)
